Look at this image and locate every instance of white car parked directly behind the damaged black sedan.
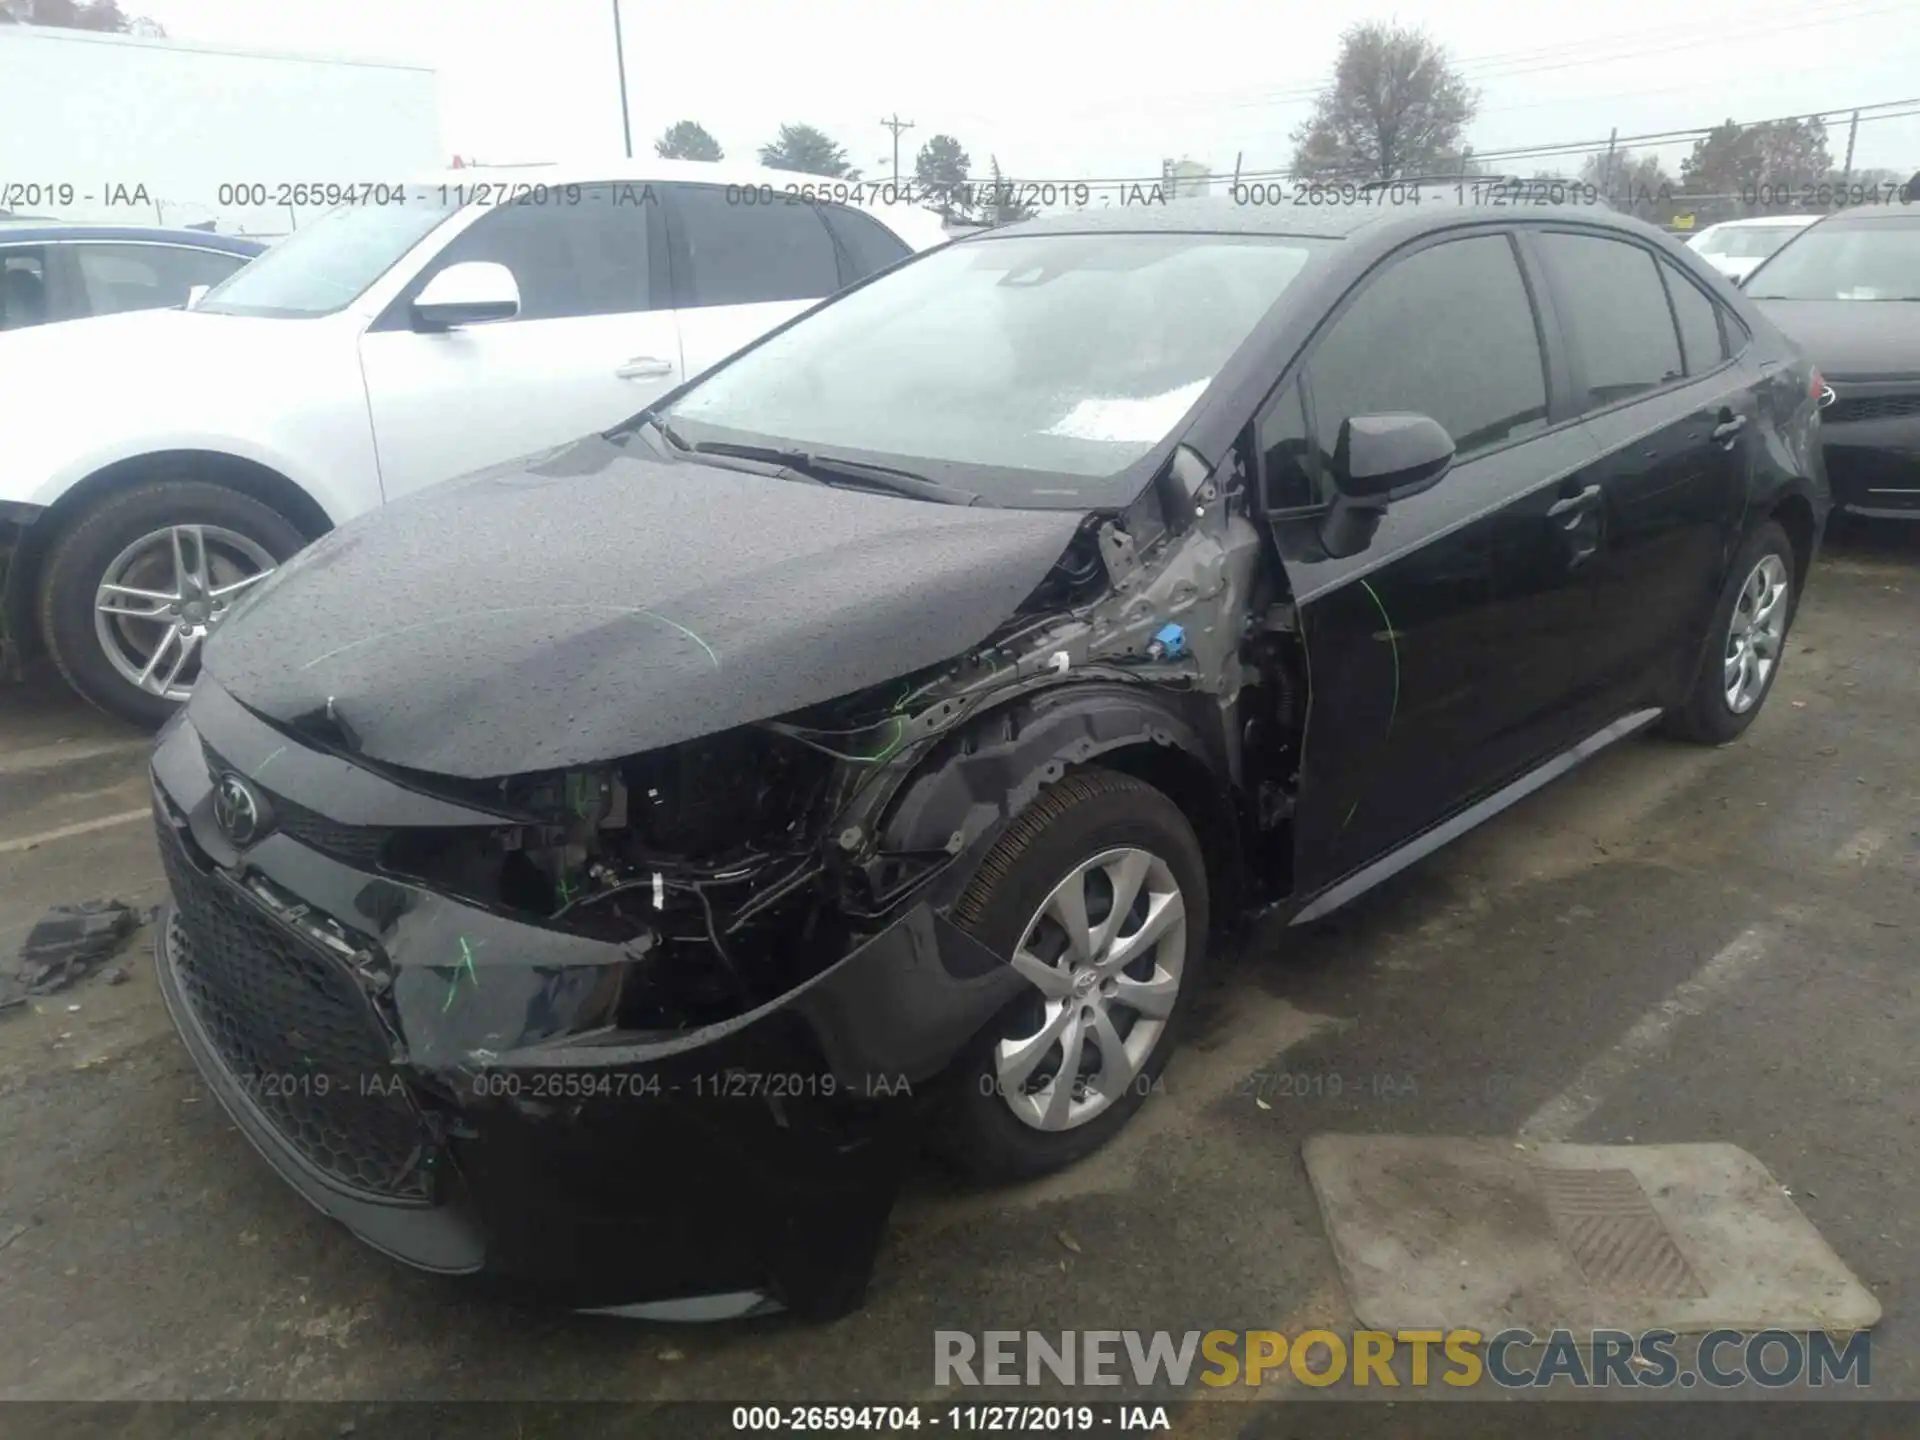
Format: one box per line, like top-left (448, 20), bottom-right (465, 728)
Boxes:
top-left (0, 161), bottom-right (947, 724)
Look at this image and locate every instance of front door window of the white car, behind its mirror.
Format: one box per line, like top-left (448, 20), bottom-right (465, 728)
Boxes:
top-left (426, 186), bottom-right (653, 323)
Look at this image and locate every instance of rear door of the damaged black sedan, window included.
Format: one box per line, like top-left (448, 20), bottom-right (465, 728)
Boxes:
top-left (1526, 228), bottom-right (1759, 712)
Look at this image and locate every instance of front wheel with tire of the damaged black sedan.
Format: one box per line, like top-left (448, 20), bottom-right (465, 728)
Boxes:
top-left (939, 770), bottom-right (1208, 1183)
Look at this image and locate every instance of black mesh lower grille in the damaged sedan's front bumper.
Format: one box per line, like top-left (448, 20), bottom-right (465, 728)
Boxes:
top-left (159, 816), bottom-right (432, 1202)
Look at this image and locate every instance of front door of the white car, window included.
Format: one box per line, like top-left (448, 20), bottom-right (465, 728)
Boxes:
top-left (361, 184), bottom-right (684, 499)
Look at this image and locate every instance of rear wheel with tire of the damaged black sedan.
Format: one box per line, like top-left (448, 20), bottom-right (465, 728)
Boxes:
top-left (1665, 520), bottom-right (1799, 745)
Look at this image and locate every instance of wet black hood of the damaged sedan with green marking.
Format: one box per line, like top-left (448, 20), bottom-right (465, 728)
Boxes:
top-left (205, 438), bottom-right (1083, 778)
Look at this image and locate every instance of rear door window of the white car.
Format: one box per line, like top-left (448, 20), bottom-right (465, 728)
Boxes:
top-left (672, 184), bottom-right (839, 307)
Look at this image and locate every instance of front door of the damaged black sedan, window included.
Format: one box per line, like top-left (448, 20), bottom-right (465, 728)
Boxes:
top-left (1256, 228), bottom-right (1594, 891)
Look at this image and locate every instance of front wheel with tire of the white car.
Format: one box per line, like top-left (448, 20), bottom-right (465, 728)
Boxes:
top-left (38, 480), bottom-right (305, 730)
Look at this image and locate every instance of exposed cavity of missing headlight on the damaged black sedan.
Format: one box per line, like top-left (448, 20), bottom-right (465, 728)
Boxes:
top-left (364, 672), bottom-right (983, 1033)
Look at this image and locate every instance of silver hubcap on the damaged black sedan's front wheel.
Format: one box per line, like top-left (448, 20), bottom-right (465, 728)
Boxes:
top-left (995, 849), bottom-right (1187, 1131)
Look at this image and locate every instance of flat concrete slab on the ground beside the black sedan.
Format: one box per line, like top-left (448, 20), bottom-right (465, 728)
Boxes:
top-left (1306, 1135), bottom-right (1880, 1334)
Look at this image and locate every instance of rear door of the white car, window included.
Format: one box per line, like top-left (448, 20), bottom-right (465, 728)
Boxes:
top-left (659, 184), bottom-right (860, 376)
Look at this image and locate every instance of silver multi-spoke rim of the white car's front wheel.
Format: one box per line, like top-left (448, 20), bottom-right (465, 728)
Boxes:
top-left (94, 524), bottom-right (275, 701)
